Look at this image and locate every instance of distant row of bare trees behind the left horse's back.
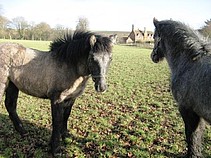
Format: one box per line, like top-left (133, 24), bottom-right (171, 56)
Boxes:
top-left (0, 15), bottom-right (89, 41)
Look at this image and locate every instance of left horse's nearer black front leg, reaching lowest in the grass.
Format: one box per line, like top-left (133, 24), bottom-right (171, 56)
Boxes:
top-left (50, 100), bottom-right (64, 155)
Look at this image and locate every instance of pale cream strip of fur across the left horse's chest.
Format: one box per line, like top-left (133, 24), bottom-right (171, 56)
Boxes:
top-left (59, 77), bottom-right (88, 102)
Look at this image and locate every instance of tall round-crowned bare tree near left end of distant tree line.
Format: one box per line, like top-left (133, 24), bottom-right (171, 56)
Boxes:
top-left (12, 16), bottom-right (28, 39)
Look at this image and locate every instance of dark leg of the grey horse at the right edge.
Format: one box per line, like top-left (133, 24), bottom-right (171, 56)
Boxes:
top-left (179, 106), bottom-right (205, 158)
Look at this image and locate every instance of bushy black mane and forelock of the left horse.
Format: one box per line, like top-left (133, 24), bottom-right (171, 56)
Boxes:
top-left (50, 31), bottom-right (111, 64)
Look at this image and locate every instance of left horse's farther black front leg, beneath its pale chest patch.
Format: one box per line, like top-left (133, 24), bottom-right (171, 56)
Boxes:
top-left (61, 99), bottom-right (75, 140)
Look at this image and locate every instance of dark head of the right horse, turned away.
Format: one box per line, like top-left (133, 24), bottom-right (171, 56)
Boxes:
top-left (151, 18), bottom-right (164, 63)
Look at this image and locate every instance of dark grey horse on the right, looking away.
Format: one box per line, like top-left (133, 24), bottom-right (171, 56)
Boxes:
top-left (151, 19), bottom-right (211, 158)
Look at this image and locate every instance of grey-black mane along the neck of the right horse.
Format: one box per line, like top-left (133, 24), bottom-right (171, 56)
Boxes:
top-left (158, 20), bottom-right (211, 57)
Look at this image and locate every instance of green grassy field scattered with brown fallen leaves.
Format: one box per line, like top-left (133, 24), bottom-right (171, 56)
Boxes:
top-left (0, 40), bottom-right (211, 158)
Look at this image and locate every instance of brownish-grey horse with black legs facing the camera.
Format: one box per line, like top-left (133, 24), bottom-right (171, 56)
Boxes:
top-left (0, 31), bottom-right (112, 155)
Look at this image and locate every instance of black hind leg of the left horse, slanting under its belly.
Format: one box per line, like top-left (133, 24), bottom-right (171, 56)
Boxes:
top-left (5, 81), bottom-right (26, 136)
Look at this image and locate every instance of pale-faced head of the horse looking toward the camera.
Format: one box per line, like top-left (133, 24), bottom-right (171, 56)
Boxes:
top-left (88, 35), bottom-right (112, 92)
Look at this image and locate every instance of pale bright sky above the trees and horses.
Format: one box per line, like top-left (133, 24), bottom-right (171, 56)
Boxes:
top-left (0, 0), bottom-right (211, 31)
